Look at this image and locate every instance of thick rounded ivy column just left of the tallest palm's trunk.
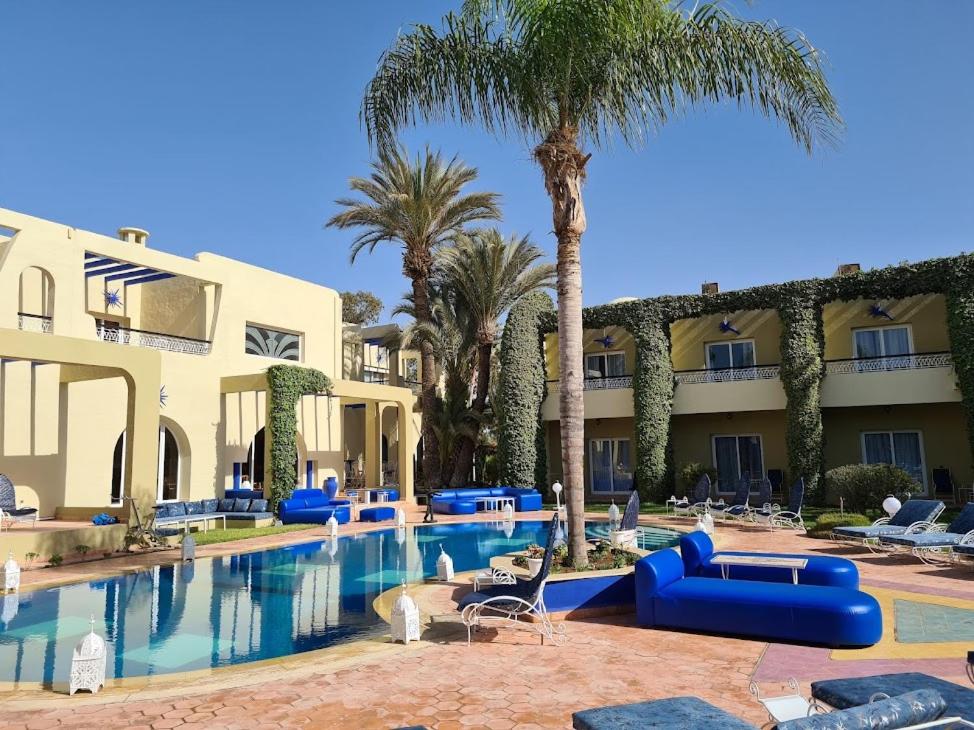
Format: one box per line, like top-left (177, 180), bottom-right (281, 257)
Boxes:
top-left (497, 292), bottom-right (554, 487)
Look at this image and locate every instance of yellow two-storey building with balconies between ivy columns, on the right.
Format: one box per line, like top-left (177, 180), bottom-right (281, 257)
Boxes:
top-left (542, 266), bottom-right (974, 501)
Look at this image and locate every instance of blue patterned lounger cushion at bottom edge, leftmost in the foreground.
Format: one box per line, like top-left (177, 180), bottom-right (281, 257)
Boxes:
top-left (572, 697), bottom-right (754, 730)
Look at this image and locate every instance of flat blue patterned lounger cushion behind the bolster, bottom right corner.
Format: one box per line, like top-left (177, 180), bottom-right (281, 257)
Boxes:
top-left (812, 672), bottom-right (974, 720)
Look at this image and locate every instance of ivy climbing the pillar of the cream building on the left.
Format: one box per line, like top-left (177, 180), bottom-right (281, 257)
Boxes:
top-left (267, 365), bottom-right (331, 509)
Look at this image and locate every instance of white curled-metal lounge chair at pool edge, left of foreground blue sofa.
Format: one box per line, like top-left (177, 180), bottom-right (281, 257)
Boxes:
top-left (458, 515), bottom-right (568, 646)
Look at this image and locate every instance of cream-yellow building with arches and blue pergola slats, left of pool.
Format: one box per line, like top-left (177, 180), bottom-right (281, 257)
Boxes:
top-left (0, 209), bottom-right (418, 548)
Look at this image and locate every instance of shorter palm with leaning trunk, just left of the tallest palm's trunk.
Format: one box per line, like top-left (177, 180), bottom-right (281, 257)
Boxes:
top-left (439, 228), bottom-right (555, 487)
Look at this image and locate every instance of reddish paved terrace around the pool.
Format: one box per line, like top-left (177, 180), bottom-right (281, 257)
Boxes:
top-left (0, 510), bottom-right (974, 730)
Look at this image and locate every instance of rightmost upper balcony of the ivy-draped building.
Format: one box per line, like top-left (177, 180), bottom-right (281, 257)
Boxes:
top-left (822, 352), bottom-right (961, 407)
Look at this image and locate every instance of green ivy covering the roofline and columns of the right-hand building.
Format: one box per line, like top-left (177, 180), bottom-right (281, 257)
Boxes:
top-left (498, 255), bottom-right (974, 500)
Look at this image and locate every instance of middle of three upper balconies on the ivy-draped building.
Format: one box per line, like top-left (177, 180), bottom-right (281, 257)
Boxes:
top-left (673, 365), bottom-right (787, 416)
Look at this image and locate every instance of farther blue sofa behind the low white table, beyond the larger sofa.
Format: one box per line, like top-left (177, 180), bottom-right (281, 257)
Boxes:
top-left (680, 530), bottom-right (859, 590)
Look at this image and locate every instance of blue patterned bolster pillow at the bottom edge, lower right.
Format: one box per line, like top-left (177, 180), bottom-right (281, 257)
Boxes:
top-left (778, 689), bottom-right (947, 730)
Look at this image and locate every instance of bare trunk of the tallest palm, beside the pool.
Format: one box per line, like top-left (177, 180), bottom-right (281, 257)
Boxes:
top-left (534, 125), bottom-right (588, 567)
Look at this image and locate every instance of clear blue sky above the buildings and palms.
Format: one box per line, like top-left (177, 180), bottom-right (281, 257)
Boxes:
top-left (0, 0), bottom-right (974, 318)
